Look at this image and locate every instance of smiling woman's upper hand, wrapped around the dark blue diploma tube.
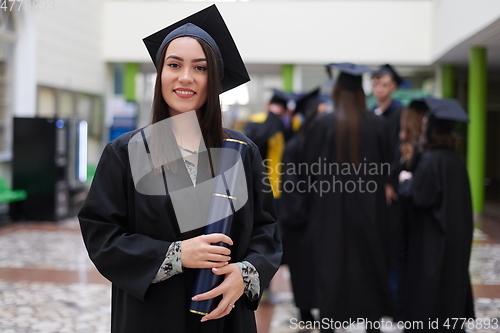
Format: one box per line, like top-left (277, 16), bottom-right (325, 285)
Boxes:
top-left (181, 234), bottom-right (233, 268)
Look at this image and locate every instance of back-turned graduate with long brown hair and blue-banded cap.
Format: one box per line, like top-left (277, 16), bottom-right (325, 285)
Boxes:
top-left (298, 63), bottom-right (392, 332)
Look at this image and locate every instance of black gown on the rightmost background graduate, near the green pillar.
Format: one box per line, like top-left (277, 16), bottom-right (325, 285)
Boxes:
top-left (403, 148), bottom-right (474, 332)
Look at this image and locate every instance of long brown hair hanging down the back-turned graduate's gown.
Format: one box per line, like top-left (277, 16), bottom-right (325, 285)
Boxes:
top-left (332, 84), bottom-right (367, 165)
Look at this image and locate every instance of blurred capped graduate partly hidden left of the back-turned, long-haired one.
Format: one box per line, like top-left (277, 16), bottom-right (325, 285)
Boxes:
top-left (280, 88), bottom-right (326, 321)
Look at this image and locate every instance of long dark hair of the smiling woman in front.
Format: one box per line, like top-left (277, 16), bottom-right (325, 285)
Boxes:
top-left (151, 37), bottom-right (227, 148)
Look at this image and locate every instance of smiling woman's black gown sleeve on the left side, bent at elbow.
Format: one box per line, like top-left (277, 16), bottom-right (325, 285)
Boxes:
top-left (78, 143), bottom-right (172, 300)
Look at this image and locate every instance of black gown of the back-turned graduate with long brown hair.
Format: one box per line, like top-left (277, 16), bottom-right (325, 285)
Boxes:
top-left (303, 113), bottom-right (392, 321)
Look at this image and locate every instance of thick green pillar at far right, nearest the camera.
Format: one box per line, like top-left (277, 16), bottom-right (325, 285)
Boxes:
top-left (467, 46), bottom-right (487, 213)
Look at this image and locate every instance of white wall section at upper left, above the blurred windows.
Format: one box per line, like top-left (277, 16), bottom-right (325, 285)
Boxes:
top-left (34, 0), bottom-right (104, 94)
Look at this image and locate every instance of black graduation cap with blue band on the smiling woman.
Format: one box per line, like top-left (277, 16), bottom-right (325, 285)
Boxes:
top-left (143, 5), bottom-right (250, 92)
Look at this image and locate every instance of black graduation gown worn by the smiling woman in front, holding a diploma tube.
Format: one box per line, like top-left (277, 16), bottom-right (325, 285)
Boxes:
top-left (78, 130), bottom-right (282, 333)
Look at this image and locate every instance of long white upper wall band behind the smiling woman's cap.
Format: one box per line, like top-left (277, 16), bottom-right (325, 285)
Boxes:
top-left (102, 0), bottom-right (432, 65)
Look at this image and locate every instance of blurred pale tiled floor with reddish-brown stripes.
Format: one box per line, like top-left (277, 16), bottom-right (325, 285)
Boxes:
top-left (0, 217), bottom-right (500, 333)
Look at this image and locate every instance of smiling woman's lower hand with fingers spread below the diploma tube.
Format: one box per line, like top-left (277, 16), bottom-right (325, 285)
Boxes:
top-left (192, 264), bottom-right (245, 321)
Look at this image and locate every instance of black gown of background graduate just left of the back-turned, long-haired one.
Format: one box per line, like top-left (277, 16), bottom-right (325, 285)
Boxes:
top-left (280, 134), bottom-right (318, 310)
